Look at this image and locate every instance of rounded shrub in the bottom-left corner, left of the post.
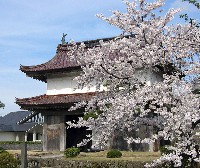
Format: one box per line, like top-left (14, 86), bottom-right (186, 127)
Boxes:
top-left (0, 151), bottom-right (19, 168)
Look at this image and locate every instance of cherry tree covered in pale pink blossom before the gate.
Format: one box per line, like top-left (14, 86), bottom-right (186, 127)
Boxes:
top-left (68, 0), bottom-right (200, 167)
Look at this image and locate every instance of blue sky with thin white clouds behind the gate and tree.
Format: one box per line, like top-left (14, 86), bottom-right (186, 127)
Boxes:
top-left (0, 0), bottom-right (200, 116)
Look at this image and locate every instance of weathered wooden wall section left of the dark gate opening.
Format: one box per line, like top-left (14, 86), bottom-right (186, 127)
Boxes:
top-left (43, 113), bottom-right (66, 151)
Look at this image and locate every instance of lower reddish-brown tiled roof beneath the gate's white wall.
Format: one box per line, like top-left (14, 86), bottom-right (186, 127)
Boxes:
top-left (16, 92), bottom-right (95, 110)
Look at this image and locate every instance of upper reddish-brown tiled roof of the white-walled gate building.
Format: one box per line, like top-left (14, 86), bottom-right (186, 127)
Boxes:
top-left (20, 38), bottom-right (116, 82)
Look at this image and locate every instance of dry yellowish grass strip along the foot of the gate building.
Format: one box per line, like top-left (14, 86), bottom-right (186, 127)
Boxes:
top-left (7, 150), bottom-right (160, 162)
